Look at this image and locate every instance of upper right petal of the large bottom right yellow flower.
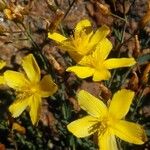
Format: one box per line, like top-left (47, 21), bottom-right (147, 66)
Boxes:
top-left (109, 89), bottom-right (134, 119)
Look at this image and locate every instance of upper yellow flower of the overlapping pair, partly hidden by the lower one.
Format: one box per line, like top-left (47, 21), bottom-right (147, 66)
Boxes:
top-left (48, 19), bottom-right (110, 62)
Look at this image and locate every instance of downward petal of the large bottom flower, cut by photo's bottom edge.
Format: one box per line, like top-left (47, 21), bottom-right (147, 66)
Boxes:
top-left (98, 130), bottom-right (118, 150)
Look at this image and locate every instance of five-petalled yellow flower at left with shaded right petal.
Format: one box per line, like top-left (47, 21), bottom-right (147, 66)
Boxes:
top-left (4, 54), bottom-right (57, 124)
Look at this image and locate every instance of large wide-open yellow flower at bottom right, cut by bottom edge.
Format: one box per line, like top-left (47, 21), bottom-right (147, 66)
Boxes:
top-left (67, 89), bottom-right (147, 150)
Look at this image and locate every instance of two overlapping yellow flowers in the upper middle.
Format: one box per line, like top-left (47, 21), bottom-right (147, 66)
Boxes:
top-left (48, 20), bottom-right (136, 81)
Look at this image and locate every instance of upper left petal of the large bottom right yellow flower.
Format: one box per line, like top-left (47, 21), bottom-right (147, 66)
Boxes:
top-left (77, 90), bottom-right (107, 118)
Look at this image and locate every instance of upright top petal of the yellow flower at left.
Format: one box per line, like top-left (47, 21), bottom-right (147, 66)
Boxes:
top-left (22, 54), bottom-right (40, 82)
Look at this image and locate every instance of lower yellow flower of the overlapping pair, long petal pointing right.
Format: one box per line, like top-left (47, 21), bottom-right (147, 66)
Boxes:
top-left (67, 38), bottom-right (136, 81)
